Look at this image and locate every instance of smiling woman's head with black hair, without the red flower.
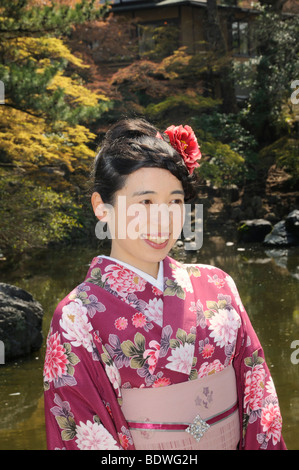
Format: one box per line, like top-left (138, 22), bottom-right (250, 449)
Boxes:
top-left (91, 115), bottom-right (202, 273)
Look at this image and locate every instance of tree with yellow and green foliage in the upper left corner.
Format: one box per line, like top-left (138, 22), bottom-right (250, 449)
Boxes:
top-left (0, 0), bottom-right (108, 171)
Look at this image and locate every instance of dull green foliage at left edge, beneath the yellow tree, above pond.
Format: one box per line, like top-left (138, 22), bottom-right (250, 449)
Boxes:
top-left (0, 171), bottom-right (82, 252)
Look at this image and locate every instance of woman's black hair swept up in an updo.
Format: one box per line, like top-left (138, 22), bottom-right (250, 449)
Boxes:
top-left (91, 118), bottom-right (200, 205)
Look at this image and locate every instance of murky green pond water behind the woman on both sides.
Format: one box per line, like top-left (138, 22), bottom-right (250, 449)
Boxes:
top-left (0, 237), bottom-right (299, 450)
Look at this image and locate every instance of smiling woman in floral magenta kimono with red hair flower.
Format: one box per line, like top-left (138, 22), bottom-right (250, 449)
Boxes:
top-left (44, 119), bottom-right (285, 450)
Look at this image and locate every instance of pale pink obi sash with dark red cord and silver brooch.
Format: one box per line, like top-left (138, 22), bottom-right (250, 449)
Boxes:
top-left (122, 366), bottom-right (240, 450)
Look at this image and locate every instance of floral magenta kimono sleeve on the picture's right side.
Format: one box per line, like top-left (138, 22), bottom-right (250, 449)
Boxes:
top-left (226, 276), bottom-right (286, 450)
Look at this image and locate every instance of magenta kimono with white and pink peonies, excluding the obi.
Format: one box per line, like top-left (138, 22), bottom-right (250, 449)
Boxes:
top-left (44, 256), bottom-right (286, 450)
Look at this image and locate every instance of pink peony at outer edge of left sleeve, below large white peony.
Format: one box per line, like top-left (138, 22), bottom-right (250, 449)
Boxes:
top-left (44, 332), bottom-right (69, 382)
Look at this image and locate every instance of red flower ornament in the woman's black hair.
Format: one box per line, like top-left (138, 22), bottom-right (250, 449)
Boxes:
top-left (156, 125), bottom-right (201, 175)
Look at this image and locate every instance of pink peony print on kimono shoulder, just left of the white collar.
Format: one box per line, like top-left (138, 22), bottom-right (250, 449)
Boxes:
top-left (102, 264), bottom-right (146, 296)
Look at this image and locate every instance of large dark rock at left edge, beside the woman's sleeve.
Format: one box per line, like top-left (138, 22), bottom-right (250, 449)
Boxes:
top-left (0, 282), bottom-right (44, 361)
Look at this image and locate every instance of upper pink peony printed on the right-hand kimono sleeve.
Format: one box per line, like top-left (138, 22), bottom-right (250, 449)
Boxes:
top-left (244, 365), bottom-right (266, 415)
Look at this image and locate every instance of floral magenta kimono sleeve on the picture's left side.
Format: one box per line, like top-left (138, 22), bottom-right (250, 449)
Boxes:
top-left (44, 299), bottom-right (134, 450)
